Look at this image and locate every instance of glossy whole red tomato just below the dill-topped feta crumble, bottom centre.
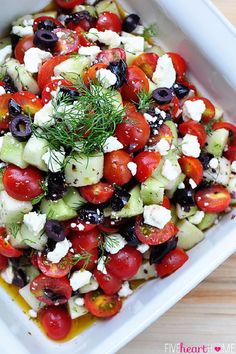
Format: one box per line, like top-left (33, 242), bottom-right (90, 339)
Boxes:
top-left (106, 245), bottom-right (142, 280)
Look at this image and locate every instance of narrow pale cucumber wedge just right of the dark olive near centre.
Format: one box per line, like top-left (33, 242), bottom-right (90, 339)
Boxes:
top-left (111, 186), bottom-right (143, 218)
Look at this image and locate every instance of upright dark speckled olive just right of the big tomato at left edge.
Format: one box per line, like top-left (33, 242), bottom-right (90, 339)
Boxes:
top-left (46, 172), bottom-right (67, 200)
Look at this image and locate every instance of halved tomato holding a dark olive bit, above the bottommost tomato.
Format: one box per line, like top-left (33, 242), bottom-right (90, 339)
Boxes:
top-left (30, 274), bottom-right (72, 305)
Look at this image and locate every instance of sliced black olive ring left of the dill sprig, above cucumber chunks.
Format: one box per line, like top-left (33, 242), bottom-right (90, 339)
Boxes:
top-left (9, 114), bottom-right (32, 141)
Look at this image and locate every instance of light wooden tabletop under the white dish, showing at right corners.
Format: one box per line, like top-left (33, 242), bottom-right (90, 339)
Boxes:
top-left (119, 0), bottom-right (236, 354)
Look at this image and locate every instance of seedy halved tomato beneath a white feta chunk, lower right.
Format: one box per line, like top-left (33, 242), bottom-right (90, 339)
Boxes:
top-left (135, 215), bottom-right (178, 246)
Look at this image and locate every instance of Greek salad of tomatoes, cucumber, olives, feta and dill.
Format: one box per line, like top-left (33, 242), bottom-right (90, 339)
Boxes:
top-left (0, 0), bottom-right (236, 340)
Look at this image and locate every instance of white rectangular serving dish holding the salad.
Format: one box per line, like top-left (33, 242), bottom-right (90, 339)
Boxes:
top-left (0, 0), bottom-right (236, 354)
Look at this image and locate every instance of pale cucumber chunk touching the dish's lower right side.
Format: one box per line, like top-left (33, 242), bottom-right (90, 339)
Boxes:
top-left (177, 220), bottom-right (205, 250)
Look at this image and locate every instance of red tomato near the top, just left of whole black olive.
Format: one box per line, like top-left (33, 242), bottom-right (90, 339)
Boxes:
top-left (96, 12), bottom-right (122, 33)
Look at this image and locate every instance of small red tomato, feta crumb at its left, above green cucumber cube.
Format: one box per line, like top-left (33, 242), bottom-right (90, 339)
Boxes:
top-left (134, 151), bottom-right (161, 183)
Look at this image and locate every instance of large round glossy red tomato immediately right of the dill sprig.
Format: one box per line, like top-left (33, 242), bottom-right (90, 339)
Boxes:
top-left (115, 112), bottom-right (150, 152)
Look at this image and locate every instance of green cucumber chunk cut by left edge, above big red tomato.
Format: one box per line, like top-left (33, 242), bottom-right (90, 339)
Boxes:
top-left (0, 134), bottom-right (28, 168)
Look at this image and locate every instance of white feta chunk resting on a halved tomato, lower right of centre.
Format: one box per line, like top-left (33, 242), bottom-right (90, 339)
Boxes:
top-left (143, 204), bottom-right (171, 229)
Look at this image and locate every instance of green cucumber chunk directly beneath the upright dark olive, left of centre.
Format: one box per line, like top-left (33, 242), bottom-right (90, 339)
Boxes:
top-left (40, 198), bottom-right (76, 221)
